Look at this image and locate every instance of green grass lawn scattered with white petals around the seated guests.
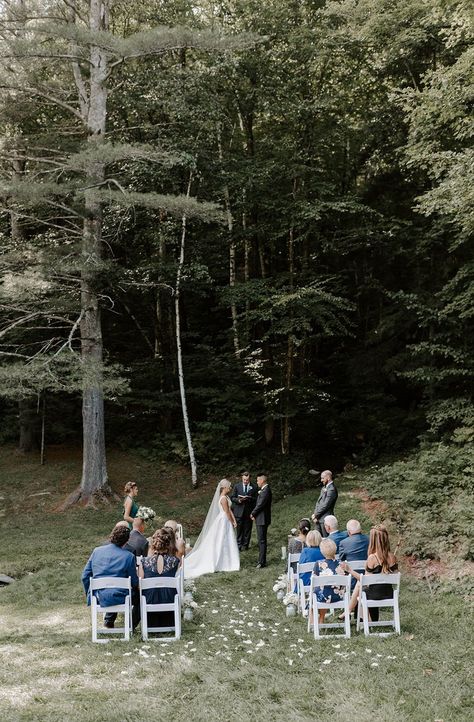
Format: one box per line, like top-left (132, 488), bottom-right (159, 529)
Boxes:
top-left (0, 449), bottom-right (473, 722)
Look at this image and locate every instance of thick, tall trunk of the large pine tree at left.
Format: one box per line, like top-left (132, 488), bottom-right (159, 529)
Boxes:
top-left (80, 0), bottom-right (109, 503)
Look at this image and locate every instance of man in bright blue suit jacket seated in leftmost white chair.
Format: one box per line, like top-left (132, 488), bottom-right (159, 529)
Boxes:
top-left (82, 524), bottom-right (140, 629)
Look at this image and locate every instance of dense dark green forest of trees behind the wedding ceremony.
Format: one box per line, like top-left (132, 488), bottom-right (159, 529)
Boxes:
top-left (0, 0), bottom-right (474, 559)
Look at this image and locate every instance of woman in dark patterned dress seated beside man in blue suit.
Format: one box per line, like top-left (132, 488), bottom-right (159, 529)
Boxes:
top-left (138, 527), bottom-right (180, 627)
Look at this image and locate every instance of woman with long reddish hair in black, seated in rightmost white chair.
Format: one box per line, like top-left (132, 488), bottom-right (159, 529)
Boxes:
top-left (344, 524), bottom-right (398, 622)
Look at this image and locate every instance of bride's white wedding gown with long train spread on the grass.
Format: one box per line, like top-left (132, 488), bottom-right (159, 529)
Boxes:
top-left (184, 501), bottom-right (240, 579)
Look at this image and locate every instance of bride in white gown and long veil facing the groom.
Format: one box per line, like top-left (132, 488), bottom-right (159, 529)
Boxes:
top-left (184, 479), bottom-right (240, 579)
